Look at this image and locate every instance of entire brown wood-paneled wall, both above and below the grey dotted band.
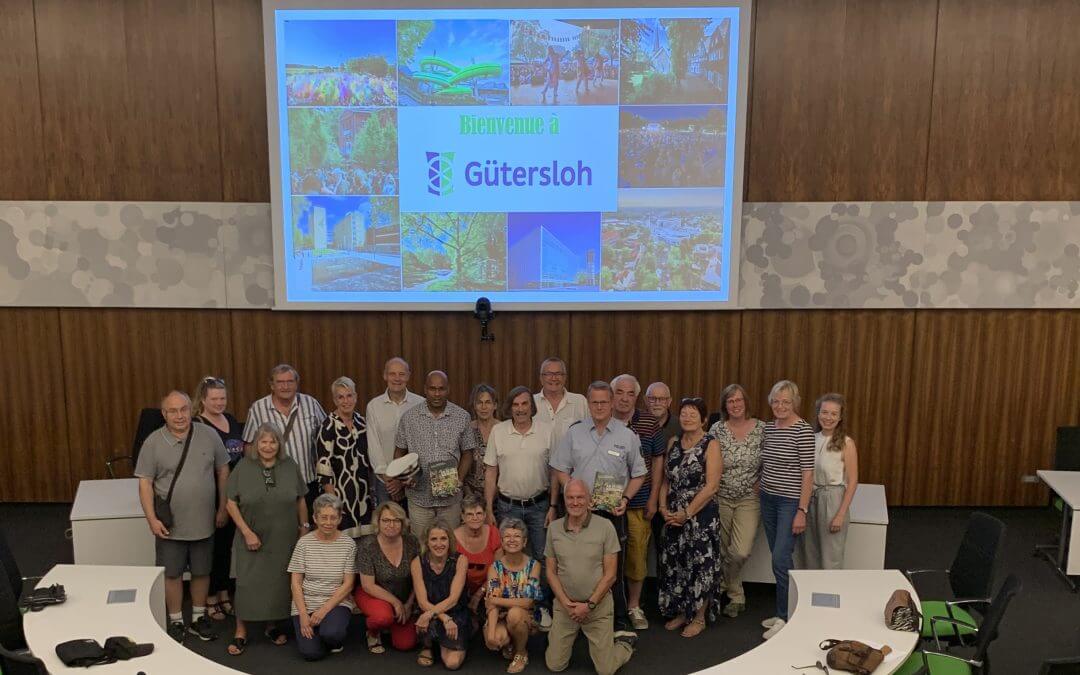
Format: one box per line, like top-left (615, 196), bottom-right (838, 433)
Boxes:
top-left (0, 0), bottom-right (1080, 504)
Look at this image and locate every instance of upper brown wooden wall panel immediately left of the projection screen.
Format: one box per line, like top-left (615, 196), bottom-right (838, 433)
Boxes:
top-left (214, 0), bottom-right (270, 202)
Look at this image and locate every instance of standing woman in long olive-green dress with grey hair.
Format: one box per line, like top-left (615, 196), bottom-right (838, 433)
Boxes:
top-left (227, 424), bottom-right (310, 656)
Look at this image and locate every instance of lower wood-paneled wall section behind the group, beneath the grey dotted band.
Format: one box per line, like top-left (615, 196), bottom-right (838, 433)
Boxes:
top-left (0, 309), bottom-right (1080, 505)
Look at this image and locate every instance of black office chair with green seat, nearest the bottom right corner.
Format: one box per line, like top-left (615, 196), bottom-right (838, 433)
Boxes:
top-left (893, 575), bottom-right (1023, 675)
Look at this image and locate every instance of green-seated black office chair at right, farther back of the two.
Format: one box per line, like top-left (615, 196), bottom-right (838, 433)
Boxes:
top-left (904, 512), bottom-right (1005, 645)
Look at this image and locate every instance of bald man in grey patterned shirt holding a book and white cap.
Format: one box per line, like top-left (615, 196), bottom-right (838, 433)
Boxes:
top-left (394, 370), bottom-right (476, 537)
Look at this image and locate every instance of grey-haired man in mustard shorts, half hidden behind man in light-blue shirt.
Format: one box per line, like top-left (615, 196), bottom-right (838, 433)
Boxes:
top-left (611, 374), bottom-right (667, 631)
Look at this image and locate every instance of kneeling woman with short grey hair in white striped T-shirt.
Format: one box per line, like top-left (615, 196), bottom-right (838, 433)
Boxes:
top-left (288, 494), bottom-right (356, 661)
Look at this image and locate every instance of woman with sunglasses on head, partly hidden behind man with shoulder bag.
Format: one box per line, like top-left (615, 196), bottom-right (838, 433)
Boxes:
top-left (191, 376), bottom-right (244, 621)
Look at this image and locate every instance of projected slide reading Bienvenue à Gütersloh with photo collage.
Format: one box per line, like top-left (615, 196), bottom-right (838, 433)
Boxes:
top-left (268, 5), bottom-right (745, 309)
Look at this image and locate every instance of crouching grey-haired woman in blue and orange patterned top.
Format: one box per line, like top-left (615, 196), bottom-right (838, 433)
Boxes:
top-left (484, 518), bottom-right (541, 673)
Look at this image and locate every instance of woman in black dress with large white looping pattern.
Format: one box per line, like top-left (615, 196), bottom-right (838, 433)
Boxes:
top-left (315, 377), bottom-right (375, 539)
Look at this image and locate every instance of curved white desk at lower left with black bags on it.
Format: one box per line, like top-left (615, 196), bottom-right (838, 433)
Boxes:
top-left (23, 565), bottom-right (240, 675)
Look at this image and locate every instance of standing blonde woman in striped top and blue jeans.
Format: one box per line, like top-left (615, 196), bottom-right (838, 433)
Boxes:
top-left (760, 380), bottom-right (814, 639)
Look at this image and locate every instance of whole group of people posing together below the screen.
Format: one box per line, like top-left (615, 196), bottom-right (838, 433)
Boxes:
top-left (135, 357), bottom-right (858, 675)
